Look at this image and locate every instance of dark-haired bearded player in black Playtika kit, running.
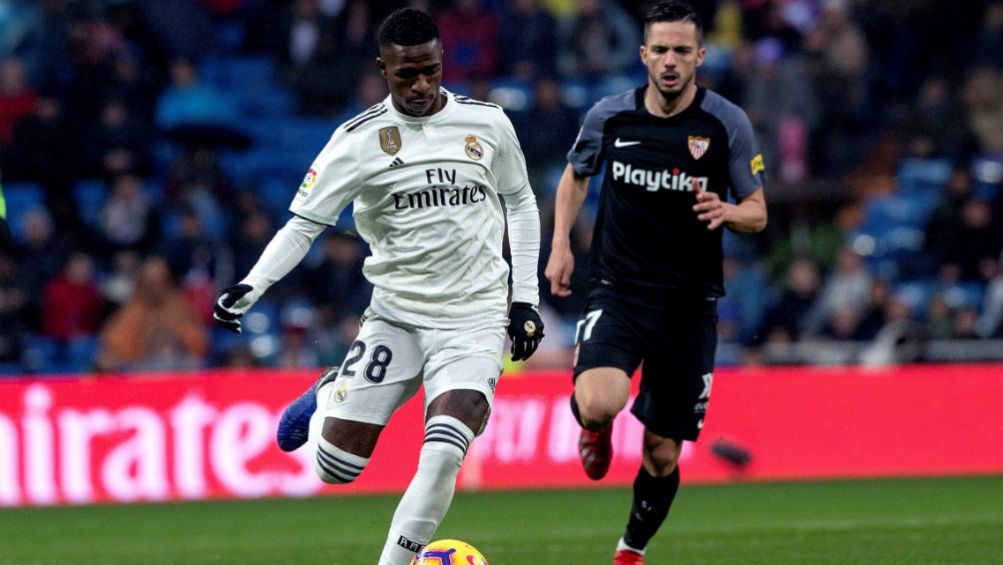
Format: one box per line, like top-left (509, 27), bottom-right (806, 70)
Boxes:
top-left (546, 2), bottom-right (766, 565)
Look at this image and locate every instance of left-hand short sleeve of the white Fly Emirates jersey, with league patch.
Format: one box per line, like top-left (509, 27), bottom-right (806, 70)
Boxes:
top-left (289, 127), bottom-right (362, 226)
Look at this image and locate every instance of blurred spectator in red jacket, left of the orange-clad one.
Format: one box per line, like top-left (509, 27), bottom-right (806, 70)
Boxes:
top-left (42, 252), bottom-right (103, 341)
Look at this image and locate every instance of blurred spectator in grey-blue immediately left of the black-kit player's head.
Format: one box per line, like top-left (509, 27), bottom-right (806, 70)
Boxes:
top-left (558, 0), bottom-right (642, 80)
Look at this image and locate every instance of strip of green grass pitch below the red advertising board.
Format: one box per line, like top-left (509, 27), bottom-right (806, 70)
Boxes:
top-left (0, 477), bottom-right (1003, 565)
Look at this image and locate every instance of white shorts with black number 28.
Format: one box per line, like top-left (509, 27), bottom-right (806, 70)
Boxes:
top-left (317, 317), bottom-right (506, 426)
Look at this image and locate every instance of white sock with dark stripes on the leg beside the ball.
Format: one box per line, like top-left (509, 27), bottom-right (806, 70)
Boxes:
top-left (379, 415), bottom-right (473, 565)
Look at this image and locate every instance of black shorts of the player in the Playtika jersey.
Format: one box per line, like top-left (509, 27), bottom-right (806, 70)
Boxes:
top-left (575, 288), bottom-right (717, 441)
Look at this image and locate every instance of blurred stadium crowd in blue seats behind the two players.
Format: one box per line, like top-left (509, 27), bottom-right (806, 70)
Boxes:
top-left (0, 0), bottom-right (1003, 374)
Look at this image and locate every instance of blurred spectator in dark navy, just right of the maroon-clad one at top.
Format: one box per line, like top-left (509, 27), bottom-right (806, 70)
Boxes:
top-left (498, 0), bottom-right (558, 80)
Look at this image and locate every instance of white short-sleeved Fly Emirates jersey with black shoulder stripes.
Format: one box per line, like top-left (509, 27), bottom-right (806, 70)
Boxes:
top-left (290, 90), bottom-right (535, 327)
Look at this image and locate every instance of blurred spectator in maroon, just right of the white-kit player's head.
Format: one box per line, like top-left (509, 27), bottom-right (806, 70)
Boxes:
top-left (438, 0), bottom-right (499, 84)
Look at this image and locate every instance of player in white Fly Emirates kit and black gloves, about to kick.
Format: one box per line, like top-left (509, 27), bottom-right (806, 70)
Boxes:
top-left (209, 8), bottom-right (544, 565)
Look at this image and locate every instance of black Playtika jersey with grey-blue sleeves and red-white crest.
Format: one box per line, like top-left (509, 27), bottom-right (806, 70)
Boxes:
top-left (568, 86), bottom-right (763, 303)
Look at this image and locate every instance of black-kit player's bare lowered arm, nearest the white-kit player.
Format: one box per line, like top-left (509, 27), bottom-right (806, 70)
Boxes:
top-left (544, 165), bottom-right (589, 297)
